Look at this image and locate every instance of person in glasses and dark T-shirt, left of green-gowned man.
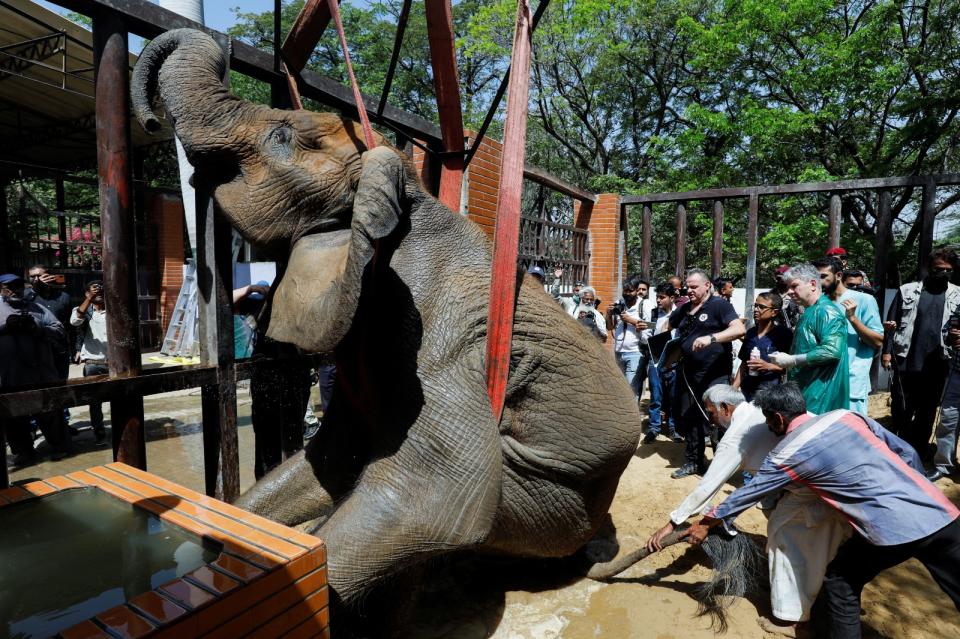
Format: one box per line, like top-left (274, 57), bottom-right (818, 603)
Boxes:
top-left (733, 291), bottom-right (793, 401)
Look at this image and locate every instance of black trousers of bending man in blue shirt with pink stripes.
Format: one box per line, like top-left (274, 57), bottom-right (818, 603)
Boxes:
top-left (811, 518), bottom-right (960, 639)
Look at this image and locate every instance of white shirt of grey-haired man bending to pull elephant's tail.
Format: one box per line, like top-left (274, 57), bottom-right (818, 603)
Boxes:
top-left (670, 402), bottom-right (781, 524)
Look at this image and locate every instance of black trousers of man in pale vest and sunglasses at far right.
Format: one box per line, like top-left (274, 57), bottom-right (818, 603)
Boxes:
top-left (891, 354), bottom-right (950, 461)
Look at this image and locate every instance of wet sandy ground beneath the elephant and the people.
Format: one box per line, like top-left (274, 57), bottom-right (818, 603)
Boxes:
top-left (11, 389), bottom-right (960, 639)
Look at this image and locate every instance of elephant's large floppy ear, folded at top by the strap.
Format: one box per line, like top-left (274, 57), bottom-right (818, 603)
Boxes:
top-left (267, 147), bottom-right (409, 352)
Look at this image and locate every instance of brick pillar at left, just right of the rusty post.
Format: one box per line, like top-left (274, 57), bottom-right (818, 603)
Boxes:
top-left (146, 193), bottom-right (185, 336)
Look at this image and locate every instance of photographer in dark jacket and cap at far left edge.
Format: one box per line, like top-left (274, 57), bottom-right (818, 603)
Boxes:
top-left (0, 273), bottom-right (69, 467)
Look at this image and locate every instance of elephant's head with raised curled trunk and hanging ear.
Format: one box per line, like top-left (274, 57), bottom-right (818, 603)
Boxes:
top-left (132, 29), bottom-right (412, 351)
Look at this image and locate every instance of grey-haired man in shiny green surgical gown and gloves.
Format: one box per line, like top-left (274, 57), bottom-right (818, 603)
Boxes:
top-left (770, 264), bottom-right (850, 415)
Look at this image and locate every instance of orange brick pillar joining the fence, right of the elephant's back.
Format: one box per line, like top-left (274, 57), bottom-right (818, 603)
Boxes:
top-left (573, 193), bottom-right (626, 356)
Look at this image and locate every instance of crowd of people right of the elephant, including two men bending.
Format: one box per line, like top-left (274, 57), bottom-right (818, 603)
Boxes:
top-left (544, 249), bottom-right (960, 638)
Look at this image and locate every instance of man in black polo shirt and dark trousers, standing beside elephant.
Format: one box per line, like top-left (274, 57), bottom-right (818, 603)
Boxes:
top-left (667, 268), bottom-right (746, 479)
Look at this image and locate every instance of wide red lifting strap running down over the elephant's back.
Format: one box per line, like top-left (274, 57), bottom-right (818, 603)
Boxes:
top-left (486, 0), bottom-right (532, 423)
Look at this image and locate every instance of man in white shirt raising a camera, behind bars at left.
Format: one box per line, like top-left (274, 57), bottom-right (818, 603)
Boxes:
top-left (70, 280), bottom-right (110, 446)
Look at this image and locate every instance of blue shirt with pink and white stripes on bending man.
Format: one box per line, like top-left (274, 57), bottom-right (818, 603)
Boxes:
top-left (707, 410), bottom-right (960, 546)
